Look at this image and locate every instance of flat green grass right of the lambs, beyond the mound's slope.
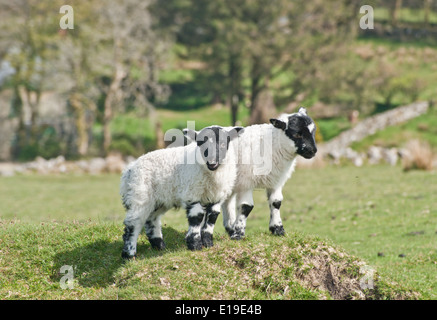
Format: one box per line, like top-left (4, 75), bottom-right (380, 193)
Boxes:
top-left (280, 166), bottom-right (437, 299)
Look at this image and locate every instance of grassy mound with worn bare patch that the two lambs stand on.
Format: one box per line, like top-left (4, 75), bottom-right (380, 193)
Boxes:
top-left (0, 220), bottom-right (418, 299)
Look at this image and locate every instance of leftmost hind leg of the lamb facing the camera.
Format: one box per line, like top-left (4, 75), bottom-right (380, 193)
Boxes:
top-left (121, 209), bottom-right (149, 259)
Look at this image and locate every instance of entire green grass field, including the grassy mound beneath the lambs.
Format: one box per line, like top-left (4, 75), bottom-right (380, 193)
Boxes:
top-left (0, 166), bottom-right (437, 299)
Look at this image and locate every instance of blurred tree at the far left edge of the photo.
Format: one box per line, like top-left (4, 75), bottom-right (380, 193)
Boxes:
top-left (0, 0), bottom-right (60, 155)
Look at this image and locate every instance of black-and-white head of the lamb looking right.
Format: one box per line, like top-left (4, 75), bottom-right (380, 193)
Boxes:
top-left (270, 108), bottom-right (317, 159)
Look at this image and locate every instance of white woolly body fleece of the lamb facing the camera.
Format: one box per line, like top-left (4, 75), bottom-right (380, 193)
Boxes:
top-left (120, 143), bottom-right (237, 214)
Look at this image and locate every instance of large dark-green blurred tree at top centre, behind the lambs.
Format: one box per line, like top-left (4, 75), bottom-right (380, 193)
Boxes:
top-left (158, 0), bottom-right (359, 123)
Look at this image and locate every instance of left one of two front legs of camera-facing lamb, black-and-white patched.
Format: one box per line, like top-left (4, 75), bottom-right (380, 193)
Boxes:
top-left (185, 202), bottom-right (205, 250)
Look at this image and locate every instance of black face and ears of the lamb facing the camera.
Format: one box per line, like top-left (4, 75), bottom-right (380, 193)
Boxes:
top-left (186, 126), bottom-right (243, 171)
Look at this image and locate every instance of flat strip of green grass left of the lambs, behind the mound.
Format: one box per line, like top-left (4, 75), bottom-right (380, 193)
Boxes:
top-left (0, 175), bottom-right (123, 222)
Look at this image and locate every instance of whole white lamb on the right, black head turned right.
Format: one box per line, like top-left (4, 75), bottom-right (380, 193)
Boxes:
top-left (222, 107), bottom-right (317, 240)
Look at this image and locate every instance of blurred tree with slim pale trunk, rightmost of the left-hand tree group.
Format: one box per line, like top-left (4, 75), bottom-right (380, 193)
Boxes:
top-left (95, 0), bottom-right (170, 153)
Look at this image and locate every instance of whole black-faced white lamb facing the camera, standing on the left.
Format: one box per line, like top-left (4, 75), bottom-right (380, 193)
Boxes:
top-left (120, 126), bottom-right (243, 259)
